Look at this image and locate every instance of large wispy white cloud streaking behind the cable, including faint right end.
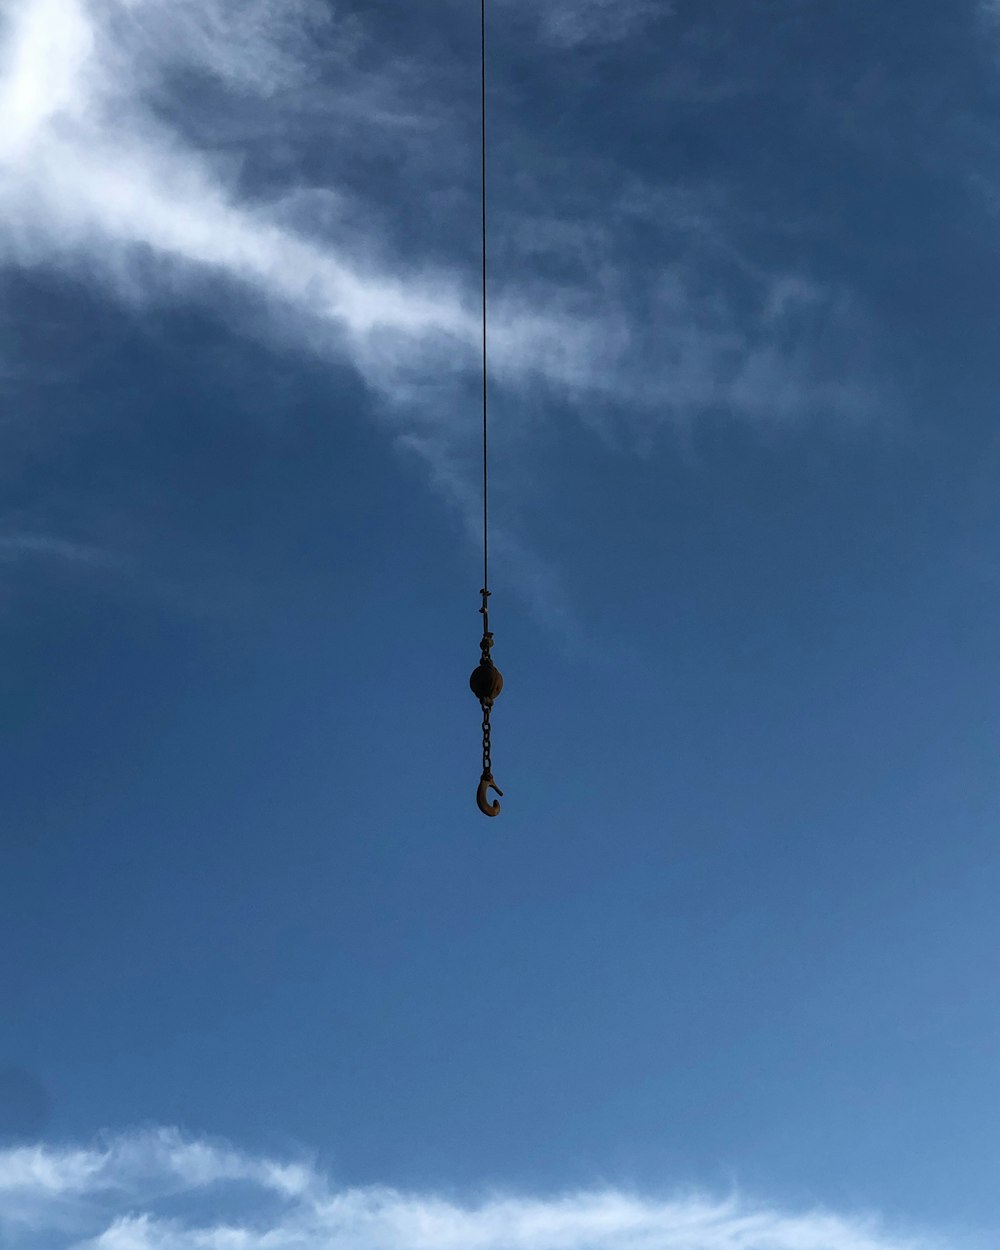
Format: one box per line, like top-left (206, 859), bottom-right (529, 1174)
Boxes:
top-left (0, 0), bottom-right (874, 622)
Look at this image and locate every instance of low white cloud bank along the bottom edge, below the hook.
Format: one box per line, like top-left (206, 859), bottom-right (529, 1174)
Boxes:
top-left (0, 1130), bottom-right (955, 1250)
